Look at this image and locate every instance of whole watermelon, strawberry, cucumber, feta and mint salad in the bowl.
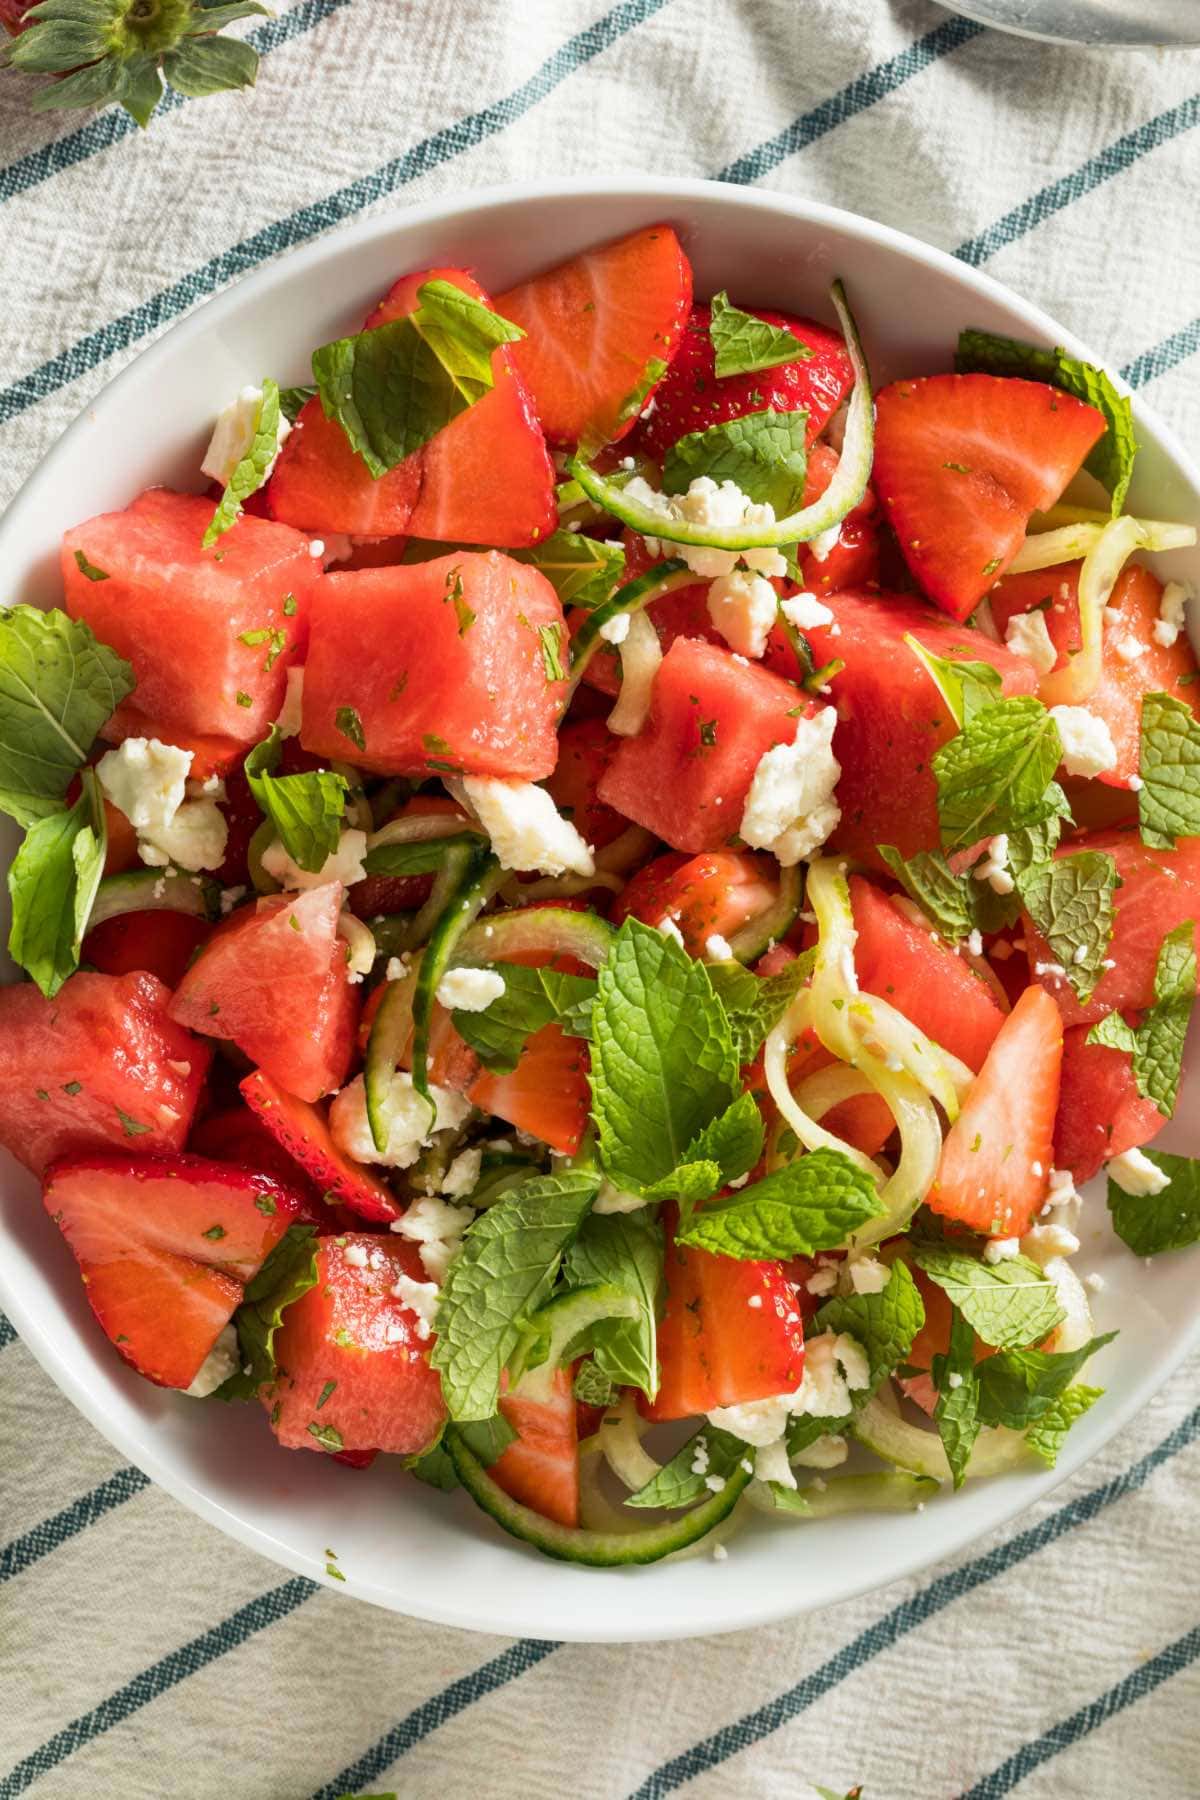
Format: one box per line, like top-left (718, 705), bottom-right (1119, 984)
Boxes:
top-left (0, 225), bottom-right (1200, 1566)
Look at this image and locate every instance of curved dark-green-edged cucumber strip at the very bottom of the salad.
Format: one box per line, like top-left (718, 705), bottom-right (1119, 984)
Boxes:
top-left (443, 1426), bottom-right (750, 1568)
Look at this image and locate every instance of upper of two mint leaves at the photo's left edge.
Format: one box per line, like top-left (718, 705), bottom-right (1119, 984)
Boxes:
top-left (0, 607), bottom-right (133, 826)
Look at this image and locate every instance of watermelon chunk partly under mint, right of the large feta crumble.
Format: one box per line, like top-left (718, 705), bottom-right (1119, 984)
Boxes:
top-left (766, 592), bottom-right (1036, 871)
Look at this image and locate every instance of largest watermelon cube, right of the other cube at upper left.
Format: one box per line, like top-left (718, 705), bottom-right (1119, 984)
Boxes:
top-left (300, 551), bottom-right (567, 781)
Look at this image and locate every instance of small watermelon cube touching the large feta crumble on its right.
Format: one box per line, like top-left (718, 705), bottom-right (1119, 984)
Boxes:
top-left (597, 637), bottom-right (820, 851)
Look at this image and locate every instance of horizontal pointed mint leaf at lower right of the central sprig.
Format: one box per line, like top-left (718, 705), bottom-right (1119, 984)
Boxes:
top-left (676, 1150), bottom-right (883, 1260)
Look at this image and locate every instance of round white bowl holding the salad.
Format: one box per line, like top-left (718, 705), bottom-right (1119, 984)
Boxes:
top-left (0, 182), bottom-right (1200, 1642)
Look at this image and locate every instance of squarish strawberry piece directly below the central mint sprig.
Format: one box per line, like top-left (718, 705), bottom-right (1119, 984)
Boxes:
top-left (639, 1208), bottom-right (804, 1420)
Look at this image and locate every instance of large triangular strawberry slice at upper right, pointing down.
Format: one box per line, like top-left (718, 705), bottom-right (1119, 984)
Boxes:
top-left (873, 374), bottom-right (1105, 619)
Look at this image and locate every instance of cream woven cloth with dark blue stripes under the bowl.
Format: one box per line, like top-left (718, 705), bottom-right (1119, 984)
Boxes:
top-left (0, 0), bottom-right (1200, 1800)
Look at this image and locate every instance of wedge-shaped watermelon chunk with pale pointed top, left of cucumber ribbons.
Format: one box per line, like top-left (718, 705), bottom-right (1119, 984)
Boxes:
top-left (171, 882), bottom-right (358, 1100)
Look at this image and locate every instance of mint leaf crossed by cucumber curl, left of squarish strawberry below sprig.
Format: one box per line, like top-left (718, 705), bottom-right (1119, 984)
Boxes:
top-left (563, 1208), bottom-right (662, 1404)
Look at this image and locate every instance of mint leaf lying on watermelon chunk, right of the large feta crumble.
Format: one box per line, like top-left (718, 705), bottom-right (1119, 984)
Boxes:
top-left (934, 695), bottom-right (1067, 850)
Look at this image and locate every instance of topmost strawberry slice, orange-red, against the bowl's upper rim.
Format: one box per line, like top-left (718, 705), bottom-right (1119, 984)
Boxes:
top-left (497, 225), bottom-right (691, 445)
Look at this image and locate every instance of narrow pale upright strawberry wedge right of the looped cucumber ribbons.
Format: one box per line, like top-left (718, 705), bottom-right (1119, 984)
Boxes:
top-left (928, 986), bottom-right (1063, 1237)
